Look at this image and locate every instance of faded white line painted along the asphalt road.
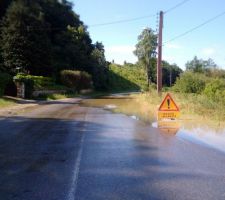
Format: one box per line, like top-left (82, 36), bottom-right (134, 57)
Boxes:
top-left (67, 114), bottom-right (87, 200)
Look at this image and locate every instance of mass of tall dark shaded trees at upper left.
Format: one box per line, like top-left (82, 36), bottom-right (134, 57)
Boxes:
top-left (0, 0), bottom-right (107, 89)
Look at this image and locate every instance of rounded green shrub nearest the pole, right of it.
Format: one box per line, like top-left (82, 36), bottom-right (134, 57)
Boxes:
top-left (173, 72), bottom-right (208, 94)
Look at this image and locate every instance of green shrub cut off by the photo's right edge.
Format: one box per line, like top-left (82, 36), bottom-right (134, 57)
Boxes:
top-left (203, 79), bottom-right (225, 102)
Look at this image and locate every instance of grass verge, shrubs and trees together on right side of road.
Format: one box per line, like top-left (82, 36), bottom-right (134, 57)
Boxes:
top-left (114, 57), bottom-right (225, 127)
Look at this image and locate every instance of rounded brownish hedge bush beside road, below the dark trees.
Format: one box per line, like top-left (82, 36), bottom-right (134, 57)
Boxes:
top-left (60, 70), bottom-right (92, 92)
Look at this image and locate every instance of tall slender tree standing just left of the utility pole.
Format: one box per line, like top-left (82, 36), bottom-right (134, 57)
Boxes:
top-left (134, 28), bottom-right (157, 85)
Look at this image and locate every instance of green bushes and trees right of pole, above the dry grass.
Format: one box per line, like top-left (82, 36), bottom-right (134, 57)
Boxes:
top-left (173, 57), bottom-right (225, 107)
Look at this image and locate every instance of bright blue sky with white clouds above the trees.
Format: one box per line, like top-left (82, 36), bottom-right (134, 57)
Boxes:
top-left (72, 0), bottom-right (225, 69)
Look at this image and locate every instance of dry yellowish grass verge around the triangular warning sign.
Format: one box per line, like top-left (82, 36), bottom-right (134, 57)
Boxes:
top-left (129, 91), bottom-right (225, 125)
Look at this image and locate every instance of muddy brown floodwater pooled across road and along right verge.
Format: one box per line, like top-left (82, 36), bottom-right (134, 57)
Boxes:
top-left (81, 94), bottom-right (225, 153)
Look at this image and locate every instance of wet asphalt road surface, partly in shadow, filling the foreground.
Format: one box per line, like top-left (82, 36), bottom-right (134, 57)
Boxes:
top-left (0, 99), bottom-right (225, 200)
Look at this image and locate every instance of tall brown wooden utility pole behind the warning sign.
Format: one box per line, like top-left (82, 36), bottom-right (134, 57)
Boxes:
top-left (157, 11), bottom-right (163, 95)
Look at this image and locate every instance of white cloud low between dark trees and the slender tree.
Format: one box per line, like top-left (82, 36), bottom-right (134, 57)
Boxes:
top-left (105, 45), bottom-right (137, 64)
